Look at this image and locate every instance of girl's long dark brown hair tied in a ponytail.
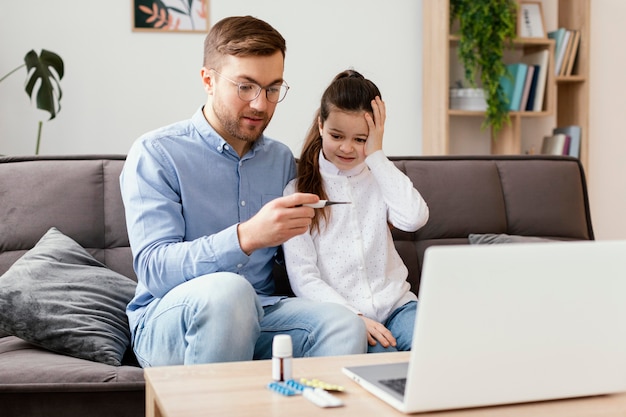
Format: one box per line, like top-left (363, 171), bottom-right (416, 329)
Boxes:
top-left (296, 70), bottom-right (381, 231)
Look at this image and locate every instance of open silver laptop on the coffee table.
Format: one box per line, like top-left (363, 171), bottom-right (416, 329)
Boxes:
top-left (343, 241), bottom-right (626, 413)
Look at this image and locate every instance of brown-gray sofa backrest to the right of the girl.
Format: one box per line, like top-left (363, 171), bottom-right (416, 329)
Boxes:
top-left (390, 155), bottom-right (594, 292)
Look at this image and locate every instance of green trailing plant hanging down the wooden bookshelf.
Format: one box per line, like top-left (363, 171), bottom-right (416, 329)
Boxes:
top-left (450, 0), bottom-right (518, 137)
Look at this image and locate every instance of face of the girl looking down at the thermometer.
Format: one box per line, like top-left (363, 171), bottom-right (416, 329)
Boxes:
top-left (318, 109), bottom-right (369, 171)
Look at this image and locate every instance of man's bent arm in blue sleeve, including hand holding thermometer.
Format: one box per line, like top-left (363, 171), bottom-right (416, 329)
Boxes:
top-left (120, 136), bottom-right (318, 297)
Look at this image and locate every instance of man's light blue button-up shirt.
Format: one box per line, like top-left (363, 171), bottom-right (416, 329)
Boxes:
top-left (120, 109), bottom-right (295, 333)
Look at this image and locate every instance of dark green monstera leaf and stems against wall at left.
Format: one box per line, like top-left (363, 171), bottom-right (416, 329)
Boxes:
top-left (0, 49), bottom-right (64, 155)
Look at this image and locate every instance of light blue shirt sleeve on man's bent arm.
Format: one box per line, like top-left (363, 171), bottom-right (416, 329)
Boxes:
top-left (120, 138), bottom-right (249, 297)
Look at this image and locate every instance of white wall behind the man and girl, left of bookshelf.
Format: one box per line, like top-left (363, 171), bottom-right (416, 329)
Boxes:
top-left (0, 0), bottom-right (422, 155)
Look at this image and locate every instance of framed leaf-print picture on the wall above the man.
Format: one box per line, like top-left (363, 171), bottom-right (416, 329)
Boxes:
top-left (132, 0), bottom-right (209, 33)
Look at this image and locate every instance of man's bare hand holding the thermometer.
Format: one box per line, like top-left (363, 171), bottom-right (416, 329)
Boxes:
top-left (237, 193), bottom-right (319, 255)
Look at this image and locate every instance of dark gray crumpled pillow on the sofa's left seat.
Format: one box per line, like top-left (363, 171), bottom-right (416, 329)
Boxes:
top-left (0, 228), bottom-right (136, 366)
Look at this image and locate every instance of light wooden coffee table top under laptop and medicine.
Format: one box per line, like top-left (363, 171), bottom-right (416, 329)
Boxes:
top-left (145, 352), bottom-right (626, 417)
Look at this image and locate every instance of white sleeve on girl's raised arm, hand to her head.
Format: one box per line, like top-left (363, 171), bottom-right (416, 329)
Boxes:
top-left (365, 151), bottom-right (429, 232)
